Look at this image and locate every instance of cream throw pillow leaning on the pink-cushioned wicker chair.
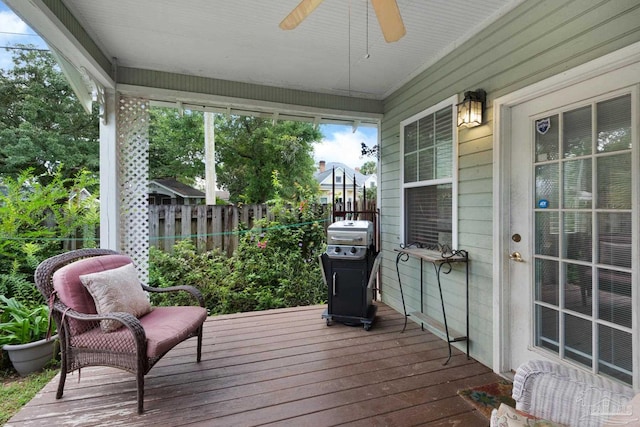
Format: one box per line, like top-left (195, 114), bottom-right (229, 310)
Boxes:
top-left (80, 264), bottom-right (151, 332)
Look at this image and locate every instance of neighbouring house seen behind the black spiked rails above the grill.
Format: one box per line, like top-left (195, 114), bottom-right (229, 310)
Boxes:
top-left (314, 160), bottom-right (369, 204)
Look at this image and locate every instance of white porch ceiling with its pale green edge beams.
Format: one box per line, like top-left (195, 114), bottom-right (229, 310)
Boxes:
top-left (4, 0), bottom-right (523, 125)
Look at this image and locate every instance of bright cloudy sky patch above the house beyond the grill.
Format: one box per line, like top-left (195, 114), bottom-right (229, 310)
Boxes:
top-left (313, 125), bottom-right (378, 168)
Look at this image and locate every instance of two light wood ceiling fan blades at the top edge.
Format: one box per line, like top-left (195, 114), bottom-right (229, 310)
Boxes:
top-left (280, 0), bottom-right (407, 43)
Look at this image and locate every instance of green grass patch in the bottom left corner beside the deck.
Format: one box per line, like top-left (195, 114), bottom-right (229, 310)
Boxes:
top-left (0, 367), bottom-right (60, 425)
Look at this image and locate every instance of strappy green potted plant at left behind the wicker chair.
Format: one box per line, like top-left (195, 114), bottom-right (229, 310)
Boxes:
top-left (0, 295), bottom-right (49, 345)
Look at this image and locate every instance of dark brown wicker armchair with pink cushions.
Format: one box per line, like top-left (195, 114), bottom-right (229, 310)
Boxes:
top-left (35, 249), bottom-right (207, 414)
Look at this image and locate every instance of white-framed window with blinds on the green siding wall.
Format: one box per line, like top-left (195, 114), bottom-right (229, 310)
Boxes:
top-left (401, 99), bottom-right (457, 248)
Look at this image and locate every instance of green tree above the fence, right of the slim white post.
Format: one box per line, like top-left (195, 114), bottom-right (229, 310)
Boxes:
top-left (216, 115), bottom-right (322, 203)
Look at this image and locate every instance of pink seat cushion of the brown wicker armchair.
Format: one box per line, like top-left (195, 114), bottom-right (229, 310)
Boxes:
top-left (71, 306), bottom-right (207, 358)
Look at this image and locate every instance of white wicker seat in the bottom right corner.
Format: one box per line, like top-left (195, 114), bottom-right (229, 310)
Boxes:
top-left (491, 360), bottom-right (640, 427)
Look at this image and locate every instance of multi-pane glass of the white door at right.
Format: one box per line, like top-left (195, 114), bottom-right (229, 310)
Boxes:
top-left (533, 95), bottom-right (637, 384)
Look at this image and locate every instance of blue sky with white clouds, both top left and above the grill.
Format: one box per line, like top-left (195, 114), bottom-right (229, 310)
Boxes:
top-left (0, 1), bottom-right (378, 168)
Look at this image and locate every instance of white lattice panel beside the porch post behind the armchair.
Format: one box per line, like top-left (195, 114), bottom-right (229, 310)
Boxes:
top-left (116, 96), bottom-right (149, 283)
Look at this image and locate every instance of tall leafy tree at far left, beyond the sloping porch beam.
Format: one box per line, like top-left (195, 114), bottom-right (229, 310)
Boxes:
top-left (0, 46), bottom-right (99, 182)
